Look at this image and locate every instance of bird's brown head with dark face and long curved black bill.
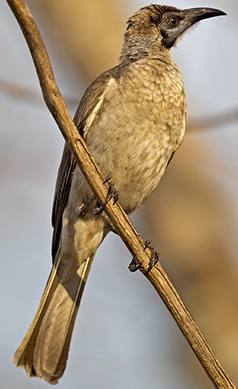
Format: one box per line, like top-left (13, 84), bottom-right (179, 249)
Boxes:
top-left (121, 4), bottom-right (226, 60)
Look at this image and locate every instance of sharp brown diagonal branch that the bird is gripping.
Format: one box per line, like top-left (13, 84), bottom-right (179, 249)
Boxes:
top-left (7, 0), bottom-right (236, 389)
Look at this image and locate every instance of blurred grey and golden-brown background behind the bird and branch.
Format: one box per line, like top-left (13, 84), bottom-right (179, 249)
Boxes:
top-left (0, 0), bottom-right (238, 389)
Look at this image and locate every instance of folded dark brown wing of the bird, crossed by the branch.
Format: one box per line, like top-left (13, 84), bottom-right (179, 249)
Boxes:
top-left (52, 66), bottom-right (120, 259)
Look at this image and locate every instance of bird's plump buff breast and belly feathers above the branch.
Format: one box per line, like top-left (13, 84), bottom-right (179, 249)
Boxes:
top-left (86, 61), bottom-right (186, 213)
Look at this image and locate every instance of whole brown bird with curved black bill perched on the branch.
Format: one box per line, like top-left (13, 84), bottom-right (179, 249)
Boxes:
top-left (14, 4), bottom-right (226, 384)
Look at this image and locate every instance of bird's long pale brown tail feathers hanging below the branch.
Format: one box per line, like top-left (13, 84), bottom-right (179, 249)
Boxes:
top-left (14, 255), bottom-right (94, 384)
